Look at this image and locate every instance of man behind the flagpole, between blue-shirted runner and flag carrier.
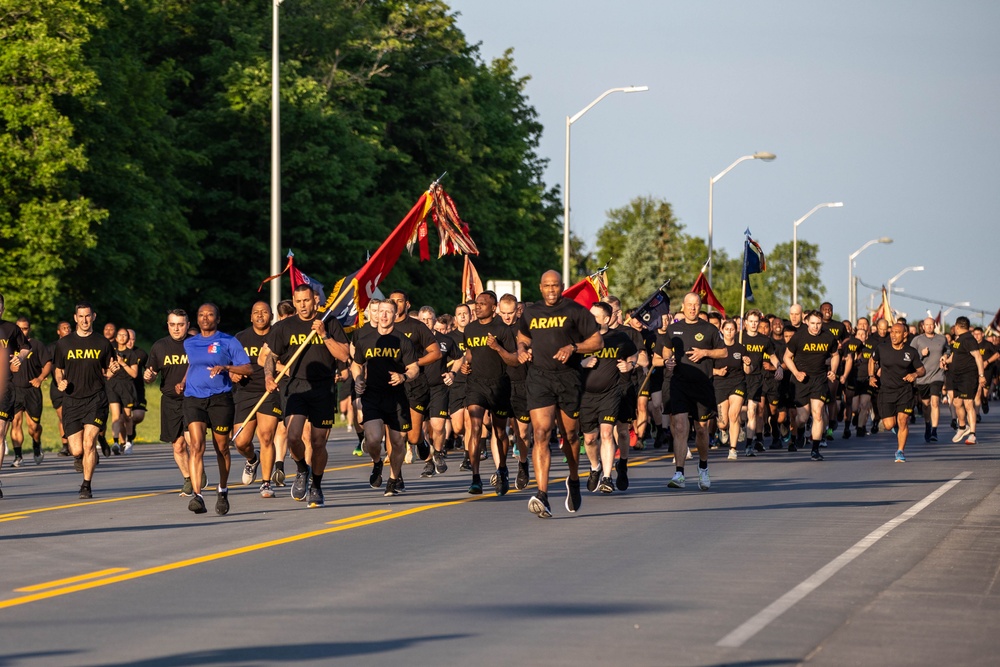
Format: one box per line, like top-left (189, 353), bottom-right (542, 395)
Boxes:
top-left (229, 301), bottom-right (283, 498)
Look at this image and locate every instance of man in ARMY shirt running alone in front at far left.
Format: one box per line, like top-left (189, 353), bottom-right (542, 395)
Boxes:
top-left (53, 303), bottom-right (119, 499)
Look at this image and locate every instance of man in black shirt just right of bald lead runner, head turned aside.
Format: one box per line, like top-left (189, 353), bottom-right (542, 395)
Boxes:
top-left (580, 302), bottom-right (639, 494)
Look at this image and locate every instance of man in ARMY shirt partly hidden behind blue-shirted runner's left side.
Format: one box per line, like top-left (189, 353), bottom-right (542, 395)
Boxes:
top-left (143, 308), bottom-right (195, 497)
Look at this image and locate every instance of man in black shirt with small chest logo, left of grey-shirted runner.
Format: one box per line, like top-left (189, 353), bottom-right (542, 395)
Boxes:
top-left (868, 322), bottom-right (924, 463)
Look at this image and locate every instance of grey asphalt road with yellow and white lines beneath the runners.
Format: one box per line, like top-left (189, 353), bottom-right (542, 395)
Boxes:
top-left (0, 416), bottom-right (1000, 666)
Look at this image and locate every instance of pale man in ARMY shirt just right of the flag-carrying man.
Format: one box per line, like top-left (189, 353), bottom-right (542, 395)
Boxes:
top-left (351, 301), bottom-right (422, 496)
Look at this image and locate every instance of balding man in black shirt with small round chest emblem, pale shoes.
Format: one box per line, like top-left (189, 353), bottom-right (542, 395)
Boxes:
top-left (653, 292), bottom-right (727, 491)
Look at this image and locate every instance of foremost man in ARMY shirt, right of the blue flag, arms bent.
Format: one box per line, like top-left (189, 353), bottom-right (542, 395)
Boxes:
top-left (785, 310), bottom-right (840, 461)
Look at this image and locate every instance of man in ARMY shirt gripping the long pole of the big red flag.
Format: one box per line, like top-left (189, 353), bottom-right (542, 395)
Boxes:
top-left (264, 284), bottom-right (348, 507)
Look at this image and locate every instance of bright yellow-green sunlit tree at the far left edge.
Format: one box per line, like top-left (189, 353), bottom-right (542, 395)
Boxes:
top-left (0, 0), bottom-right (107, 325)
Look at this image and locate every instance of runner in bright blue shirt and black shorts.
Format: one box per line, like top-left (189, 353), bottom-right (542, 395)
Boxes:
top-left (183, 303), bottom-right (252, 516)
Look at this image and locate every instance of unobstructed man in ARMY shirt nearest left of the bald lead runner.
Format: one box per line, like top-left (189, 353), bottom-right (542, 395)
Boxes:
top-left (462, 291), bottom-right (518, 496)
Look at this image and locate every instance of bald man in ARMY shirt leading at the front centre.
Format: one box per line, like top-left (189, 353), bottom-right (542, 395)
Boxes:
top-left (517, 271), bottom-right (603, 518)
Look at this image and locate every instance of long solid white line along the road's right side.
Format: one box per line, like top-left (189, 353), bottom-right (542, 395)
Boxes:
top-left (715, 470), bottom-right (972, 648)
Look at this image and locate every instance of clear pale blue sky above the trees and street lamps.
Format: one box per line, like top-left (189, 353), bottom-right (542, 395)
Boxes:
top-left (450, 0), bottom-right (1000, 323)
